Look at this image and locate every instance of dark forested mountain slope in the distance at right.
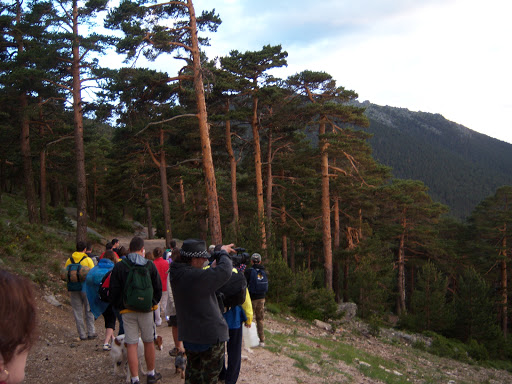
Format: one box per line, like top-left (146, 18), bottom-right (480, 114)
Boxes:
top-left (360, 102), bottom-right (512, 218)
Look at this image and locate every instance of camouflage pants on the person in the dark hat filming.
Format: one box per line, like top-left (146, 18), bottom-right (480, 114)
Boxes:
top-left (185, 343), bottom-right (224, 384)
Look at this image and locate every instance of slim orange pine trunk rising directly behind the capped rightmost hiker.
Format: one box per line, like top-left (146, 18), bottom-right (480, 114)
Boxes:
top-left (251, 92), bottom-right (267, 253)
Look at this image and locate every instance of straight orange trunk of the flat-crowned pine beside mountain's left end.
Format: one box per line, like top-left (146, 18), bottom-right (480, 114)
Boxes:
top-left (319, 121), bottom-right (332, 290)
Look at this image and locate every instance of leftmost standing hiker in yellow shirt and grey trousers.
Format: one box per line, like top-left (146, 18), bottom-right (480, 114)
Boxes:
top-left (64, 241), bottom-right (97, 340)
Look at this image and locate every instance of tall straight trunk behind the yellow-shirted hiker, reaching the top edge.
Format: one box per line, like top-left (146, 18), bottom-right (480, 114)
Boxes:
top-left (71, 0), bottom-right (87, 242)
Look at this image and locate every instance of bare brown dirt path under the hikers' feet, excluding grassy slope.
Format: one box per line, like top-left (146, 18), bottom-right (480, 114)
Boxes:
top-left (25, 286), bottom-right (340, 384)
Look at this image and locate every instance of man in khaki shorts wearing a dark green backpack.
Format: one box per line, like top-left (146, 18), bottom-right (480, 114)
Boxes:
top-left (110, 236), bottom-right (162, 384)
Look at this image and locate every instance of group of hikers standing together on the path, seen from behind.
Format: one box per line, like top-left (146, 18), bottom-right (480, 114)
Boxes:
top-left (61, 237), bottom-right (265, 384)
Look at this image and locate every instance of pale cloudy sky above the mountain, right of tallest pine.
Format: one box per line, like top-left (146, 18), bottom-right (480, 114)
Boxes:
top-left (102, 0), bottom-right (512, 143)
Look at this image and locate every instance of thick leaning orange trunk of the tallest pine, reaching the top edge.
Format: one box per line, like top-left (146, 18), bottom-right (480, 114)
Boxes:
top-left (187, 0), bottom-right (222, 244)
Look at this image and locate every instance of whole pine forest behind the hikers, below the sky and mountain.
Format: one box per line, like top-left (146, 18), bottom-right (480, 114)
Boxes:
top-left (0, 0), bottom-right (512, 359)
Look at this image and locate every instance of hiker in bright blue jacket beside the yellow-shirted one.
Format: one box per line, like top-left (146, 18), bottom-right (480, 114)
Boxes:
top-left (85, 250), bottom-right (123, 351)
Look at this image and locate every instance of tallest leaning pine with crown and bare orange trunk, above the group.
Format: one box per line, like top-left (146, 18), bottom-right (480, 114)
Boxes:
top-left (107, 0), bottom-right (222, 244)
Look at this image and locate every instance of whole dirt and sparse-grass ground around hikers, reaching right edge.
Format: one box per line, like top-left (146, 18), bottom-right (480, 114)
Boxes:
top-left (25, 232), bottom-right (512, 384)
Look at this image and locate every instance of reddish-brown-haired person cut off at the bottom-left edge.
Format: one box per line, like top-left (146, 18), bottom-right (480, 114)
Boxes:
top-left (0, 269), bottom-right (36, 384)
